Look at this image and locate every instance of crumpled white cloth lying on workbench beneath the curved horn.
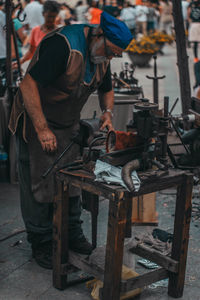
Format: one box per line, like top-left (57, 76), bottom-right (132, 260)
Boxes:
top-left (94, 160), bottom-right (140, 192)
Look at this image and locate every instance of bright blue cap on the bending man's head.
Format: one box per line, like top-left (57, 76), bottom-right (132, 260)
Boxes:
top-left (100, 11), bottom-right (133, 49)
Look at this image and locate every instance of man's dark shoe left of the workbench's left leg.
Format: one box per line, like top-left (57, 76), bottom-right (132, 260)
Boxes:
top-left (32, 241), bottom-right (53, 270)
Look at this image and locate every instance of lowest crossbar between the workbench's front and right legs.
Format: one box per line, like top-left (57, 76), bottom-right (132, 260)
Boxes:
top-left (121, 268), bottom-right (168, 293)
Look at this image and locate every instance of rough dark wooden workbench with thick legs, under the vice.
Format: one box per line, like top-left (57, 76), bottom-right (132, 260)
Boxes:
top-left (53, 170), bottom-right (193, 300)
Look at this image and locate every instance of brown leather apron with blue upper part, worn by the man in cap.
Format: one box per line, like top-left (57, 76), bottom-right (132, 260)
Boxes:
top-left (9, 25), bottom-right (109, 202)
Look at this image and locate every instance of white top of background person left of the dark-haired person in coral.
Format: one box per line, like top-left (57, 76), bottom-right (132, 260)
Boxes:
top-left (23, 1), bottom-right (44, 29)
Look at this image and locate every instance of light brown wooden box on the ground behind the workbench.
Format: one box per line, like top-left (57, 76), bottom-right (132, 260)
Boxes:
top-left (132, 193), bottom-right (158, 225)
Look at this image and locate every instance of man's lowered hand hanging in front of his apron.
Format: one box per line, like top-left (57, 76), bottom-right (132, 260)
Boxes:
top-left (37, 128), bottom-right (57, 152)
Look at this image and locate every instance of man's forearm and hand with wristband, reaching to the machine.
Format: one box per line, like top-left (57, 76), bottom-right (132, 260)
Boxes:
top-left (99, 90), bottom-right (114, 130)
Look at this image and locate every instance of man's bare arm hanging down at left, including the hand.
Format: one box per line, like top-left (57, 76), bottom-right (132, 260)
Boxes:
top-left (20, 74), bottom-right (57, 152)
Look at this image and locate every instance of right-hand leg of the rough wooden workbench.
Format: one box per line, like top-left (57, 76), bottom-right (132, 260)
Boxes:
top-left (168, 175), bottom-right (193, 298)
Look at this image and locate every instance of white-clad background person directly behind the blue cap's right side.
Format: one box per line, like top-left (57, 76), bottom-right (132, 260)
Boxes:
top-left (120, 2), bottom-right (136, 38)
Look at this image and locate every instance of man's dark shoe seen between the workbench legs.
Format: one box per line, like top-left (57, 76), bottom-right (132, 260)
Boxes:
top-left (69, 235), bottom-right (93, 255)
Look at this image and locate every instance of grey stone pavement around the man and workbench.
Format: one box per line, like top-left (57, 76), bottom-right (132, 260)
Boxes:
top-left (0, 46), bottom-right (200, 300)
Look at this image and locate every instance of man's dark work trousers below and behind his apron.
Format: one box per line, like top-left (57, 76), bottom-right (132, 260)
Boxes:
top-left (17, 126), bottom-right (83, 246)
